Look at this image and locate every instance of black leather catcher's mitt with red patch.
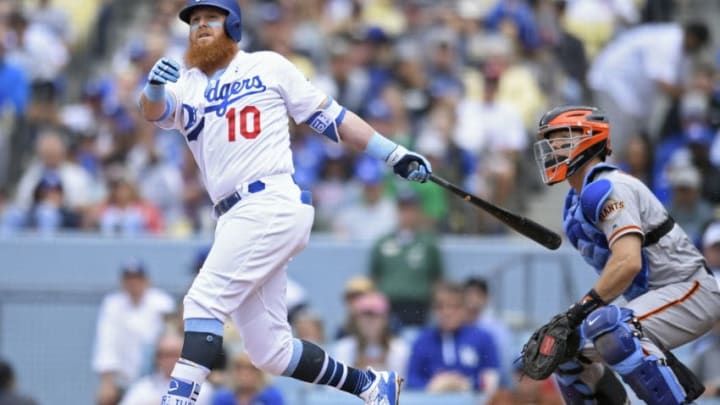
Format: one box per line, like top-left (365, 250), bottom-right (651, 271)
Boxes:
top-left (522, 314), bottom-right (580, 380)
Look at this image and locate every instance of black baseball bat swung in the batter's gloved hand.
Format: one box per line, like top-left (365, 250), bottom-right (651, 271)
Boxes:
top-left (430, 174), bottom-right (562, 250)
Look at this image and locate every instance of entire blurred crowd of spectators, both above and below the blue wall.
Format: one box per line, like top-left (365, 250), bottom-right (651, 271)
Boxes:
top-left (0, 0), bottom-right (720, 405)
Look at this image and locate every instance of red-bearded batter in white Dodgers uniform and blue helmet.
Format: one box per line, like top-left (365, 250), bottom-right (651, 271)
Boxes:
top-left (140, 0), bottom-right (431, 405)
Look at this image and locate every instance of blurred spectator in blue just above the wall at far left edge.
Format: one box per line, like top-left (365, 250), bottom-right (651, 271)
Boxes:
top-left (1, 173), bottom-right (81, 235)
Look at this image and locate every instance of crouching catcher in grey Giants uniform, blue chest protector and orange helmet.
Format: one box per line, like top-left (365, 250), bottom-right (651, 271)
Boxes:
top-left (534, 106), bottom-right (720, 405)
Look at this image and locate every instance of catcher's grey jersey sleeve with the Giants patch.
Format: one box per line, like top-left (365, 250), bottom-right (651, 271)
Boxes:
top-left (598, 182), bottom-right (644, 246)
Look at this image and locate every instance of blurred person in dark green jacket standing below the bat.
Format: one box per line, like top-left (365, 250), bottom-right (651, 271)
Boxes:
top-left (370, 189), bottom-right (444, 326)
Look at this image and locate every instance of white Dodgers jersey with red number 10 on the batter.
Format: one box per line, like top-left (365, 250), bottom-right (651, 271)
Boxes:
top-left (157, 51), bottom-right (326, 203)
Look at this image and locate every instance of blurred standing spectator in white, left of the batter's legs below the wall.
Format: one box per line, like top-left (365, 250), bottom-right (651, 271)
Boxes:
top-left (92, 261), bottom-right (175, 405)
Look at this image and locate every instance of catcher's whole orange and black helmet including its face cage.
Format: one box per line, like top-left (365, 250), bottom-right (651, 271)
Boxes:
top-left (533, 106), bottom-right (611, 185)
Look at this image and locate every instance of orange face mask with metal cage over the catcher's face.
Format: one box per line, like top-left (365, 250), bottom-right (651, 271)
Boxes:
top-left (533, 126), bottom-right (592, 185)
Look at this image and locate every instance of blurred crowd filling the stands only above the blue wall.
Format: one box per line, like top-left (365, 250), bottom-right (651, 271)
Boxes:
top-left (0, 0), bottom-right (720, 240)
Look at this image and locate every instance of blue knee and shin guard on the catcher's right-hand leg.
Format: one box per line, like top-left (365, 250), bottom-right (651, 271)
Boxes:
top-left (582, 305), bottom-right (685, 405)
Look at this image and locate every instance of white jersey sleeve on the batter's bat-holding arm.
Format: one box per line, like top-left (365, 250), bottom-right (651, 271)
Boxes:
top-left (273, 54), bottom-right (327, 124)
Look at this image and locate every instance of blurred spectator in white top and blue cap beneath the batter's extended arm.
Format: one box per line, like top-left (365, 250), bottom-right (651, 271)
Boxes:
top-left (333, 157), bottom-right (397, 241)
